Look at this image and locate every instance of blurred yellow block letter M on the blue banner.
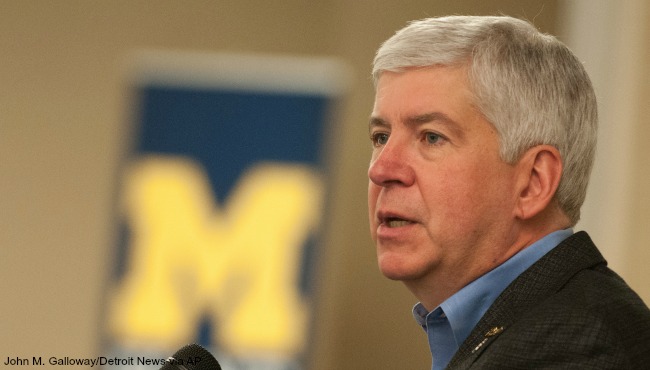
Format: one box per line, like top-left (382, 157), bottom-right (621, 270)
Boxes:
top-left (110, 157), bottom-right (323, 356)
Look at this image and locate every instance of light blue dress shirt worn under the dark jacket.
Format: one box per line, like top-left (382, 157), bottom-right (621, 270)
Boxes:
top-left (413, 229), bottom-right (573, 370)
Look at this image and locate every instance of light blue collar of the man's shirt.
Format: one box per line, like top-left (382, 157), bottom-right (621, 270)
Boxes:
top-left (413, 228), bottom-right (573, 347)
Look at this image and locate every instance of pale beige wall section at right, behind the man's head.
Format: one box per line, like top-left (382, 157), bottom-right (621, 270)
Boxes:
top-left (558, 0), bottom-right (650, 302)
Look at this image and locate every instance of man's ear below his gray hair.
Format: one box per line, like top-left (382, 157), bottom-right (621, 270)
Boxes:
top-left (515, 145), bottom-right (562, 220)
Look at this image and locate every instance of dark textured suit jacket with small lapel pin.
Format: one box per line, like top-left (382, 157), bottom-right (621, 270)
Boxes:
top-left (447, 232), bottom-right (650, 370)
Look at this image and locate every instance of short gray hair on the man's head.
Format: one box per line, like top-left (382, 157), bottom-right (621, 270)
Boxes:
top-left (372, 16), bottom-right (598, 225)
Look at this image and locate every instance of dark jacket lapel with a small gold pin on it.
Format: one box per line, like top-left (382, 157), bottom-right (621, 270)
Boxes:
top-left (447, 232), bottom-right (606, 369)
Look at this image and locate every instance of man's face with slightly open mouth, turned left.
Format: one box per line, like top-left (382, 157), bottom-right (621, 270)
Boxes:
top-left (368, 67), bottom-right (516, 289)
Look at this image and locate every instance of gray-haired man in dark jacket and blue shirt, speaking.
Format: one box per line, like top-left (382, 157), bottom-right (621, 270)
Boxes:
top-left (368, 16), bottom-right (650, 369)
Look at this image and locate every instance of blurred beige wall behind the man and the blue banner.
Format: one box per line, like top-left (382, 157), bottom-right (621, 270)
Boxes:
top-left (0, 0), bottom-right (650, 369)
